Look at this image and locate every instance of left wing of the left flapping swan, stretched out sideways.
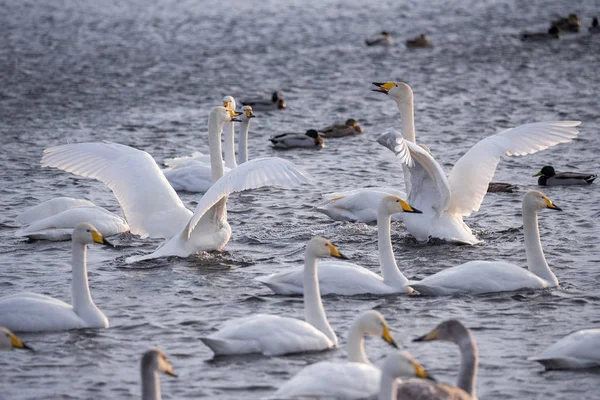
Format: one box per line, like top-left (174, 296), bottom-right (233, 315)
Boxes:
top-left (41, 142), bottom-right (192, 238)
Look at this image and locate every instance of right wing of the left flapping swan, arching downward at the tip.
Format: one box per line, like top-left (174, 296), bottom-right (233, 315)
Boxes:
top-left (184, 157), bottom-right (313, 239)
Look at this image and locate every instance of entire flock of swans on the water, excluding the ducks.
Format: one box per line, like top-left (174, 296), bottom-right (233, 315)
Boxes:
top-left (0, 82), bottom-right (600, 400)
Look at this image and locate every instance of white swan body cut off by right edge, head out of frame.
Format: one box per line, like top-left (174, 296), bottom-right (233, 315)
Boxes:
top-left (529, 328), bottom-right (600, 370)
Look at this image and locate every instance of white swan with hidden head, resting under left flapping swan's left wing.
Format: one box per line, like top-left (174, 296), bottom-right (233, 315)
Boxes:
top-left (15, 197), bottom-right (129, 240)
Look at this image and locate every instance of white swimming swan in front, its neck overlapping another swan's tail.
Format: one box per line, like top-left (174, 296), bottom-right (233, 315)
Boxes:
top-left (200, 237), bottom-right (346, 356)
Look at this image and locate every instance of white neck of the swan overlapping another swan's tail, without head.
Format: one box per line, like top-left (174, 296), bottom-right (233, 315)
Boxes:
top-left (304, 251), bottom-right (337, 345)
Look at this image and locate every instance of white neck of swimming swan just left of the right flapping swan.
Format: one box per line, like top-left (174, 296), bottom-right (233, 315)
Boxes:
top-left (377, 204), bottom-right (408, 288)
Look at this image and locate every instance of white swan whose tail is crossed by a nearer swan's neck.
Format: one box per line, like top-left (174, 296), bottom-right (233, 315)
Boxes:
top-left (257, 196), bottom-right (420, 296)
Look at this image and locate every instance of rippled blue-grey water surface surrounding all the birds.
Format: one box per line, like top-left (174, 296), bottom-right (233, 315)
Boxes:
top-left (0, 0), bottom-right (600, 399)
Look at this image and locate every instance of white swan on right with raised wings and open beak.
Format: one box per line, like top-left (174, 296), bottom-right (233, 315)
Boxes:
top-left (374, 82), bottom-right (581, 244)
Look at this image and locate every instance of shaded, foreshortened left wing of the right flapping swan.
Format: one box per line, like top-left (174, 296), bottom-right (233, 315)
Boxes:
top-left (384, 131), bottom-right (450, 215)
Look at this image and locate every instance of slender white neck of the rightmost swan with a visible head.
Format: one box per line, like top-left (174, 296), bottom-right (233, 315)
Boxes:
top-left (523, 205), bottom-right (558, 286)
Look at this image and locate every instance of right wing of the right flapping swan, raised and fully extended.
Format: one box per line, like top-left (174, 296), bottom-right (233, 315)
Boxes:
top-left (448, 121), bottom-right (581, 216)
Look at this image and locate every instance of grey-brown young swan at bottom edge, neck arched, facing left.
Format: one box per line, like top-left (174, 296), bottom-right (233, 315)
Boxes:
top-left (394, 320), bottom-right (479, 400)
